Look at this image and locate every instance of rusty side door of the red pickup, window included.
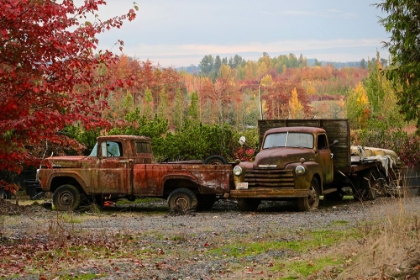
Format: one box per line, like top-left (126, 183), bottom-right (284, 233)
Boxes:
top-left (95, 141), bottom-right (131, 194)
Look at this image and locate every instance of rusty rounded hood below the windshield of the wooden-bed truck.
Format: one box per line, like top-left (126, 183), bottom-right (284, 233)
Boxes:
top-left (253, 147), bottom-right (314, 169)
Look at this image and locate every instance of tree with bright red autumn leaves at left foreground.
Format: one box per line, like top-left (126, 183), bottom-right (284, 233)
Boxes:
top-left (0, 0), bottom-right (137, 171)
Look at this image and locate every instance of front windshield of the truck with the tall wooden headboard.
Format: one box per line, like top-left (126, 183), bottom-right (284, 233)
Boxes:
top-left (263, 132), bottom-right (314, 150)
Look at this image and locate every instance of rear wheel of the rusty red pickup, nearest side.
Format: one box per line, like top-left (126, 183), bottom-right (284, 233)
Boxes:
top-left (168, 188), bottom-right (198, 214)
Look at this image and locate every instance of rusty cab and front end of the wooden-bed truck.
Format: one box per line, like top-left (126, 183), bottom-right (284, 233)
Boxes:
top-left (230, 127), bottom-right (334, 199)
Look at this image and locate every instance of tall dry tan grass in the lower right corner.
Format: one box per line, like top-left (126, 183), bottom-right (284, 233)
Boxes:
top-left (337, 197), bottom-right (420, 279)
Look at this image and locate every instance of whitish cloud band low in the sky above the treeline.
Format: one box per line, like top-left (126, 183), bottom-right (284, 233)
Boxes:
top-left (118, 38), bottom-right (383, 67)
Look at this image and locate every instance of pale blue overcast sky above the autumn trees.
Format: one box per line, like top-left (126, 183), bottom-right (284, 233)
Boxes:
top-left (89, 0), bottom-right (389, 67)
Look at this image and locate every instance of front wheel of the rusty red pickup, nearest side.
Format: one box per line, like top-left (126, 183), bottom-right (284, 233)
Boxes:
top-left (53, 185), bottom-right (81, 211)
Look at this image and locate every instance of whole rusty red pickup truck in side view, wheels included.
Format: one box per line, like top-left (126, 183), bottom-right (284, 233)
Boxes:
top-left (37, 135), bottom-right (232, 211)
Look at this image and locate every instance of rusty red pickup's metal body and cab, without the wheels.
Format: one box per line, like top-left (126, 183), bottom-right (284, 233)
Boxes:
top-left (38, 135), bottom-right (232, 201)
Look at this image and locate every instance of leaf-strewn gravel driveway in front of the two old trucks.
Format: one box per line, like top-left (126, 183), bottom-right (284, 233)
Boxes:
top-left (0, 197), bottom-right (420, 279)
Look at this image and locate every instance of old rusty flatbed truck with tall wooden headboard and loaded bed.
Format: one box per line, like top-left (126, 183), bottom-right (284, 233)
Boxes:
top-left (228, 119), bottom-right (400, 211)
